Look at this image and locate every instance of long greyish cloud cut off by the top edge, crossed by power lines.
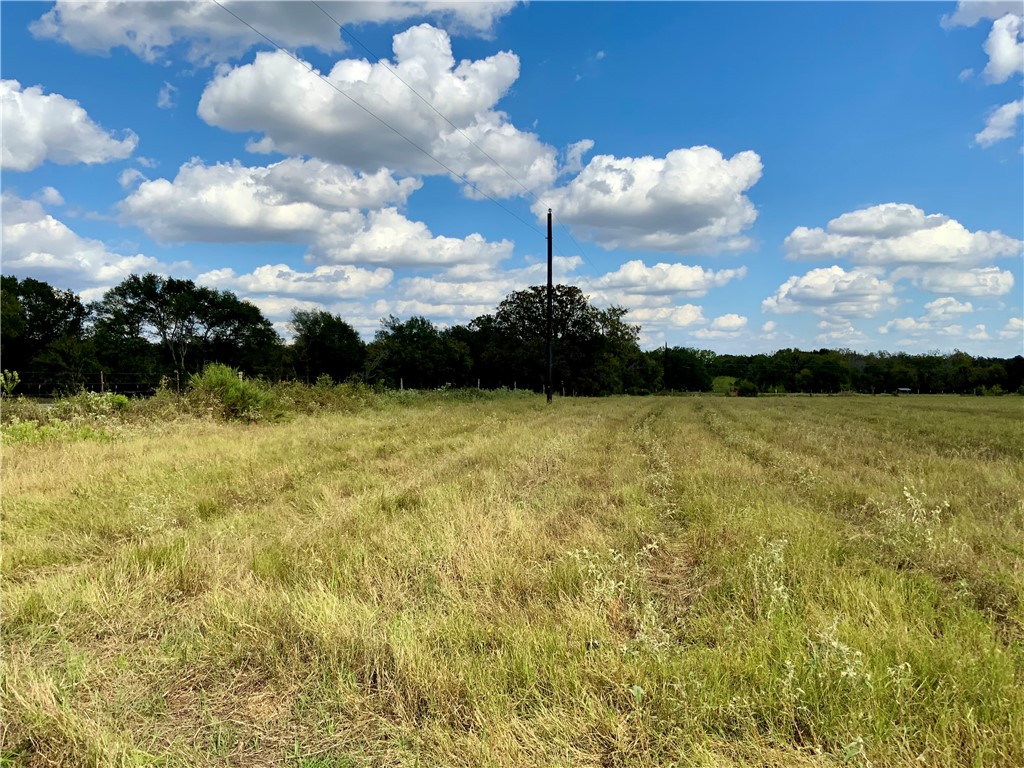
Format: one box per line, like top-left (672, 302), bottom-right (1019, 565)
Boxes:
top-left (30, 0), bottom-right (515, 63)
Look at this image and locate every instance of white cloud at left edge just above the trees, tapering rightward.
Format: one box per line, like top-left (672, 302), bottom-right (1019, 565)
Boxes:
top-left (2, 193), bottom-right (168, 290)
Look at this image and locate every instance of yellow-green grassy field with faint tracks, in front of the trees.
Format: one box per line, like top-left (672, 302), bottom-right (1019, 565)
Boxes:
top-left (0, 395), bottom-right (1024, 768)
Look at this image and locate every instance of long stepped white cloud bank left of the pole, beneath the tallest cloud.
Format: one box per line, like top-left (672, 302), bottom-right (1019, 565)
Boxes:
top-left (120, 158), bottom-right (512, 266)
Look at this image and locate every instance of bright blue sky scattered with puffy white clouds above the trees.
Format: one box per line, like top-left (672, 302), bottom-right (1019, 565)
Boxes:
top-left (0, 0), bottom-right (1024, 356)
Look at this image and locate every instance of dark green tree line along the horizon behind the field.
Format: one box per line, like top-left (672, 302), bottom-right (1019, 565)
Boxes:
top-left (0, 273), bottom-right (1024, 395)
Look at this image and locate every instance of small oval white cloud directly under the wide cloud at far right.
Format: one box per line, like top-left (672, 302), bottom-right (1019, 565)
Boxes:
top-left (761, 266), bottom-right (896, 317)
